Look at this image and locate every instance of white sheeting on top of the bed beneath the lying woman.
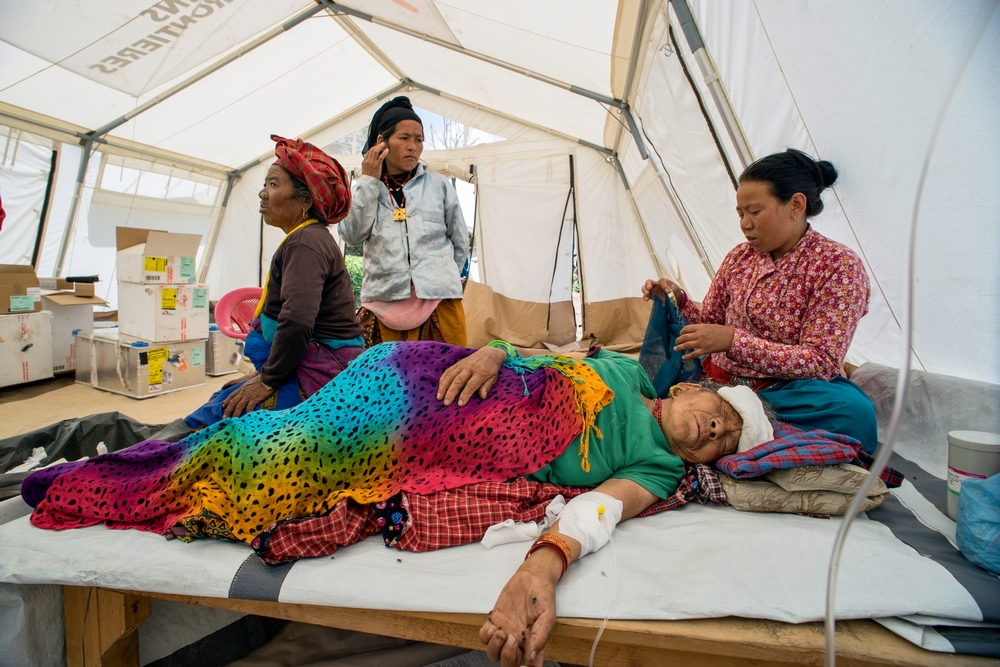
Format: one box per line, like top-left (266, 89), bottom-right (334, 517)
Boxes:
top-left (0, 505), bottom-right (982, 623)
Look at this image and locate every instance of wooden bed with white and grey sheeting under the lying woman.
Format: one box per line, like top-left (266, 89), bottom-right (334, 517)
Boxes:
top-left (0, 367), bottom-right (1000, 667)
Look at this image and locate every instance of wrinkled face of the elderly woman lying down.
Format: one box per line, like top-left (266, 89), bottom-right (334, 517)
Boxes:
top-left (660, 385), bottom-right (743, 463)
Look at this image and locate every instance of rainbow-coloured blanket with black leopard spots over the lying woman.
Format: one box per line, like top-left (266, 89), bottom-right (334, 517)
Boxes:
top-left (22, 342), bottom-right (613, 543)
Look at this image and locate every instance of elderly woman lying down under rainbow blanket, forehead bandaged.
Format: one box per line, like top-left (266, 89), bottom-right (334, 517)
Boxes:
top-left (22, 341), bottom-right (770, 664)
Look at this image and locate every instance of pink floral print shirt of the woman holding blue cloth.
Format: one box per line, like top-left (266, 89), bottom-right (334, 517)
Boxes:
top-left (681, 227), bottom-right (871, 380)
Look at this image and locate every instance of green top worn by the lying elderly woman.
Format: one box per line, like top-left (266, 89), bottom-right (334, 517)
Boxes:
top-left (525, 350), bottom-right (684, 498)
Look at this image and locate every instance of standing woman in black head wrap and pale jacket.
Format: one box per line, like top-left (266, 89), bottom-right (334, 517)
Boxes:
top-left (340, 97), bottom-right (469, 347)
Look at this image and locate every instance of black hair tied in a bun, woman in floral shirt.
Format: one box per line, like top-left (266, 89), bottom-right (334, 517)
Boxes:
top-left (740, 148), bottom-right (837, 218)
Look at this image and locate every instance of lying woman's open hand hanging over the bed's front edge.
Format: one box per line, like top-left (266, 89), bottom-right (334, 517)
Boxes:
top-left (479, 549), bottom-right (562, 667)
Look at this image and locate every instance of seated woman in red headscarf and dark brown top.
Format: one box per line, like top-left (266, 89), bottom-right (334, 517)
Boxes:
top-left (186, 135), bottom-right (364, 428)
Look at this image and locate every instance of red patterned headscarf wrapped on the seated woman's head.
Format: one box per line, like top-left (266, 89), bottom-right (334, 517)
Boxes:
top-left (271, 134), bottom-right (351, 225)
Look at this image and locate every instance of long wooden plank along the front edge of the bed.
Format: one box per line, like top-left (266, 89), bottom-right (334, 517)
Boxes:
top-left (135, 593), bottom-right (1000, 667)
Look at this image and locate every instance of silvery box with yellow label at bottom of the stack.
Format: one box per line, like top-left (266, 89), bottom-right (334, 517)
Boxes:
top-left (76, 329), bottom-right (205, 398)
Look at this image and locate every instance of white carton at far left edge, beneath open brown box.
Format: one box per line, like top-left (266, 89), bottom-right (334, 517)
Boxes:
top-left (0, 310), bottom-right (52, 388)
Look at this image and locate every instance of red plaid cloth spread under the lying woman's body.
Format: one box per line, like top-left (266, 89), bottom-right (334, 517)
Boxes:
top-left (252, 466), bottom-right (725, 565)
